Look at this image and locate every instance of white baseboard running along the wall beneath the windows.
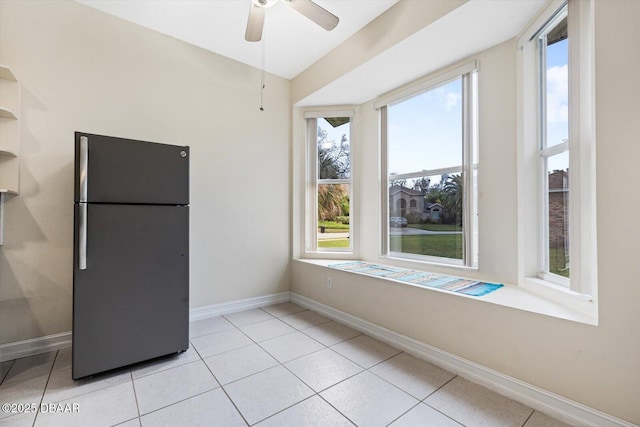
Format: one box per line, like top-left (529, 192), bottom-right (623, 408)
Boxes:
top-left (291, 292), bottom-right (637, 427)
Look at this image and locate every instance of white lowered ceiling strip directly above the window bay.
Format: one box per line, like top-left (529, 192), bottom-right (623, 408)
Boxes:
top-left (295, 0), bottom-right (546, 107)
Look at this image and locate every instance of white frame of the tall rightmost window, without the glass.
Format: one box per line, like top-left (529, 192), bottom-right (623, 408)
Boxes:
top-left (517, 0), bottom-right (597, 310)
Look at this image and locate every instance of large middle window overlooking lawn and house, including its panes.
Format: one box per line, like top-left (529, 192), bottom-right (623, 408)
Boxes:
top-left (377, 63), bottom-right (477, 266)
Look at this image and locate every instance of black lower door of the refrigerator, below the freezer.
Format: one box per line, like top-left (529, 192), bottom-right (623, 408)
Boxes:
top-left (72, 204), bottom-right (189, 379)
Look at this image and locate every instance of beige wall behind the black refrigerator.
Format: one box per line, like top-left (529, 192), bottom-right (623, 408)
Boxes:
top-left (0, 0), bottom-right (291, 344)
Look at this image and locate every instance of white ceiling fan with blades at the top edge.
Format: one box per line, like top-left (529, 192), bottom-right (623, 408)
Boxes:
top-left (244, 0), bottom-right (339, 42)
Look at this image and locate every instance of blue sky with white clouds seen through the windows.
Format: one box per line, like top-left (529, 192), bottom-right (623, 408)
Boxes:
top-left (318, 36), bottom-right (568, 183)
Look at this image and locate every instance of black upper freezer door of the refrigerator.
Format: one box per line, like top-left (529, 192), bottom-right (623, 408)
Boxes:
top-left (75, 132), bottom-right (189, 205)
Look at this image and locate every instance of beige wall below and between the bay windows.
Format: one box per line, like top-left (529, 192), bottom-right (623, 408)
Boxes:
top-left (292, 0), bottom-right (640, 424)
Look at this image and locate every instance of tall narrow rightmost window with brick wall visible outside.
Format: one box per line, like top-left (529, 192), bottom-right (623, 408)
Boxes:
top-left (518, 0), bottom-right (597, 298)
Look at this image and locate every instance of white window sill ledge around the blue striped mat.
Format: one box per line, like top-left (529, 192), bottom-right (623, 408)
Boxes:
top-left (295, 259), bottom-right (598, 325)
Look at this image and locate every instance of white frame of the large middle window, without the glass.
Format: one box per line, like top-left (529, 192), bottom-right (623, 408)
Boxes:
top-left (374, 61), bottom-right (479, 269)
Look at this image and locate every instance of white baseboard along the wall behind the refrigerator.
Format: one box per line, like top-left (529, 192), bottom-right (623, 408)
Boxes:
top-left (0, 292), bottom-right (289, 362)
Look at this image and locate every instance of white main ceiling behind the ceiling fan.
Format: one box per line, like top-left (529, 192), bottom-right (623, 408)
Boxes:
top-left (76, 0), bottom-right (398, 79)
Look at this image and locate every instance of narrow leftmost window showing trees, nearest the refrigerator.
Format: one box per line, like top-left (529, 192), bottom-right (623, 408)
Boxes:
top-left (306, 113), bottom-right (353, 252)
